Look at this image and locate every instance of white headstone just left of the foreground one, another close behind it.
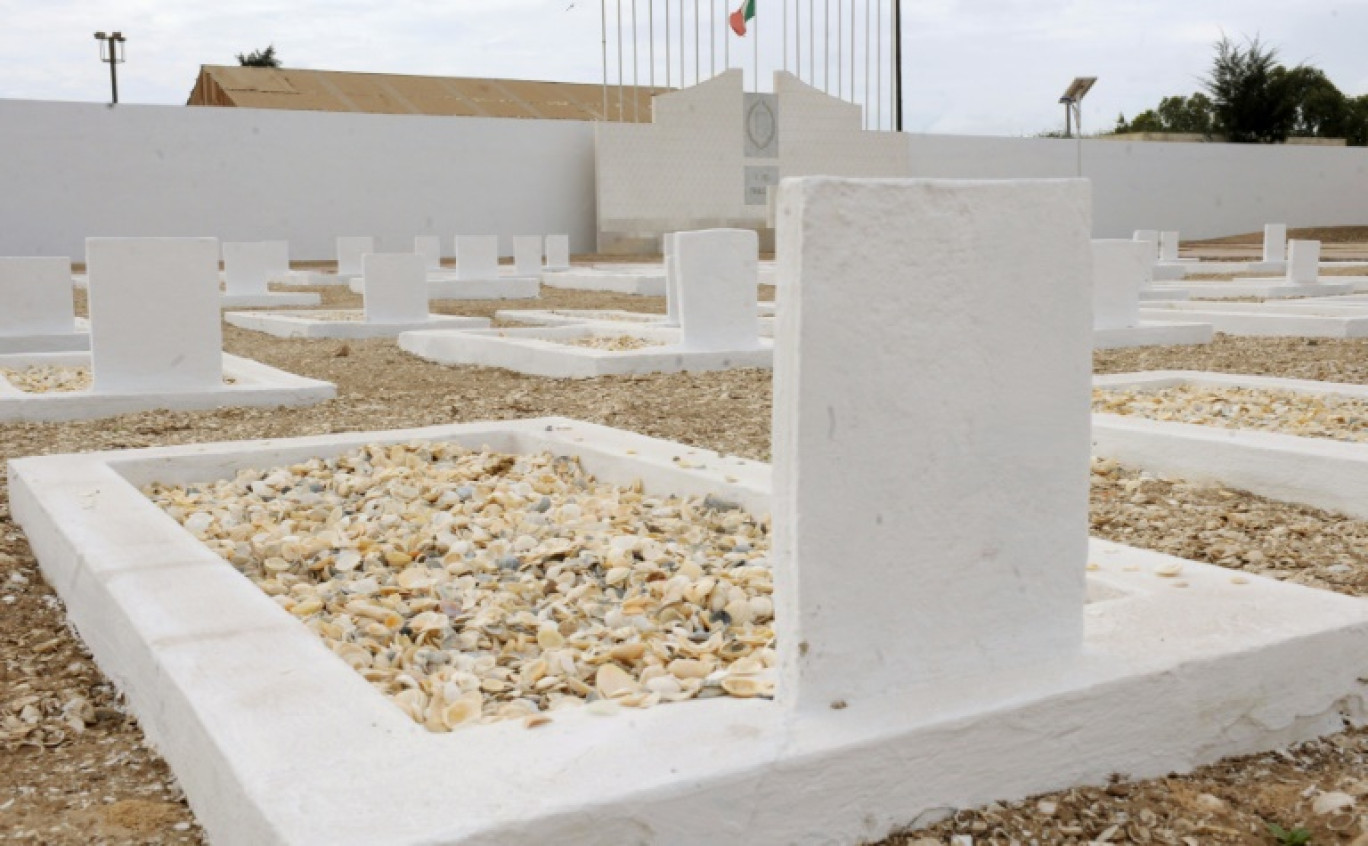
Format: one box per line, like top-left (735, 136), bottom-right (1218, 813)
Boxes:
top-left (666, 229), bottom-right (759, 350)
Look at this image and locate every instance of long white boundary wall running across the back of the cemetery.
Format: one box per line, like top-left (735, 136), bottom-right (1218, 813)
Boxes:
top-left (0, 90), bottom-right (1368, 261)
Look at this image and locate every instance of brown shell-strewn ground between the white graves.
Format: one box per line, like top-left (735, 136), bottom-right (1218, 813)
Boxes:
top-left (8, 289), bottom-right (1368, 846)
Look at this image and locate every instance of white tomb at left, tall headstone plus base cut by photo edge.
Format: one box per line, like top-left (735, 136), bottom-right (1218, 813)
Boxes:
top-left (0, 238), bottom-right (335, 420)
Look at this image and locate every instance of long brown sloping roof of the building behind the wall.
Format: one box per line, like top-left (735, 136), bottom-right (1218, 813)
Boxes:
top-left (186, 64), bottom-right (672, 123)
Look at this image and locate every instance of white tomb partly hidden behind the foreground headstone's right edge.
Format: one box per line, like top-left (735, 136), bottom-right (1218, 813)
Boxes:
top-left (1092, 238), bottom-right (1213, 349)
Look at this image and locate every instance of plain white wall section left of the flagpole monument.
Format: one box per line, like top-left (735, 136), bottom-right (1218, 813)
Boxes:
top-left (0, 100), bottom-right (594, 261)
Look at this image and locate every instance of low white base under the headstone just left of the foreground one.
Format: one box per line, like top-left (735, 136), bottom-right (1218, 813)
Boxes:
top-left (399, 324), bottom-right (774, 379)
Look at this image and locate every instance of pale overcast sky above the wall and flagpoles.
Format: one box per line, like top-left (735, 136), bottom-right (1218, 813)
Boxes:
top-left (0, 0), bottom-right (1368, 136)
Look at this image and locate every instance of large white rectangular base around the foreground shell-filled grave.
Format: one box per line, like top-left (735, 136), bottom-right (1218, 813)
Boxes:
top-left (10, 419), bottom-right (1368, 846)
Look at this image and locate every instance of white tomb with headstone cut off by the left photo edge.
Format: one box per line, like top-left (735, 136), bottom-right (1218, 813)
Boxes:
top-left (0, 256), bottom-right (90, 353)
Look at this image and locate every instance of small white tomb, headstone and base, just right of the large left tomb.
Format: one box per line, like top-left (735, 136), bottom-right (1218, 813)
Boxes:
top-left (224, 253), bottom-right (490, 338)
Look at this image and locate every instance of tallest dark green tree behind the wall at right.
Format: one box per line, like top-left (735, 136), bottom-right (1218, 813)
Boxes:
top-left (1202, 37), bottom-right (1302, 144)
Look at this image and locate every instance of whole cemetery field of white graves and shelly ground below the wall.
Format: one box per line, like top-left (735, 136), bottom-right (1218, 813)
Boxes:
top-left (0, 179), bottom-right (1368, 843)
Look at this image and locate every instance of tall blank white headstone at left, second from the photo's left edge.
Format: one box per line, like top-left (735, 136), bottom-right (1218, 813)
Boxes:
top-left (86, 238), bottom-right (223, 393)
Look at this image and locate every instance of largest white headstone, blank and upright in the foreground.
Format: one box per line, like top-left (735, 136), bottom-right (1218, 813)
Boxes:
top-left (773, 178), bottom-right (1092, 713)
